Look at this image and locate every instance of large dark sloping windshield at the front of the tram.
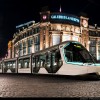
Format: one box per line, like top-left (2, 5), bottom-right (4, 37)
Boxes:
top-left (64, 42), bottom-right (96, 63)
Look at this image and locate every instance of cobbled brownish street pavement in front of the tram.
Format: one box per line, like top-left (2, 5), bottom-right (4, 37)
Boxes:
top-left (0, 74), bottom-right (100, 97)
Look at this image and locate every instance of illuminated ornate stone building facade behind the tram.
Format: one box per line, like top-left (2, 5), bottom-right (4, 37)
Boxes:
top-left (6, 11), bottom-right (100, 61)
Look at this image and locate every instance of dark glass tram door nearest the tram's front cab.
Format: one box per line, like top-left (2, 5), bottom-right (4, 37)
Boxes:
top-left (45, 50), bottom-right (62, 73)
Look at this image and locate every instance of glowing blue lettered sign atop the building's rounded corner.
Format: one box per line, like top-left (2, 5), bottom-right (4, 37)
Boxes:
top-left (50, 13), bottom-right (80, 25)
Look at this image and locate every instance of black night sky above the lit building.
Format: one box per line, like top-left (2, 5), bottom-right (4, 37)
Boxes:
top-left (0, 0), bottom-right (100, 57)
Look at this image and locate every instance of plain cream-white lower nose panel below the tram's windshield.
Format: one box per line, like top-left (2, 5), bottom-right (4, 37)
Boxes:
top-left (56, 64), bottom-right (100, 75)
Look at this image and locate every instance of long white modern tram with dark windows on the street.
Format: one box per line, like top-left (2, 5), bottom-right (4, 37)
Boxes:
top-left (0, 41), bottom-right (100, 76)
